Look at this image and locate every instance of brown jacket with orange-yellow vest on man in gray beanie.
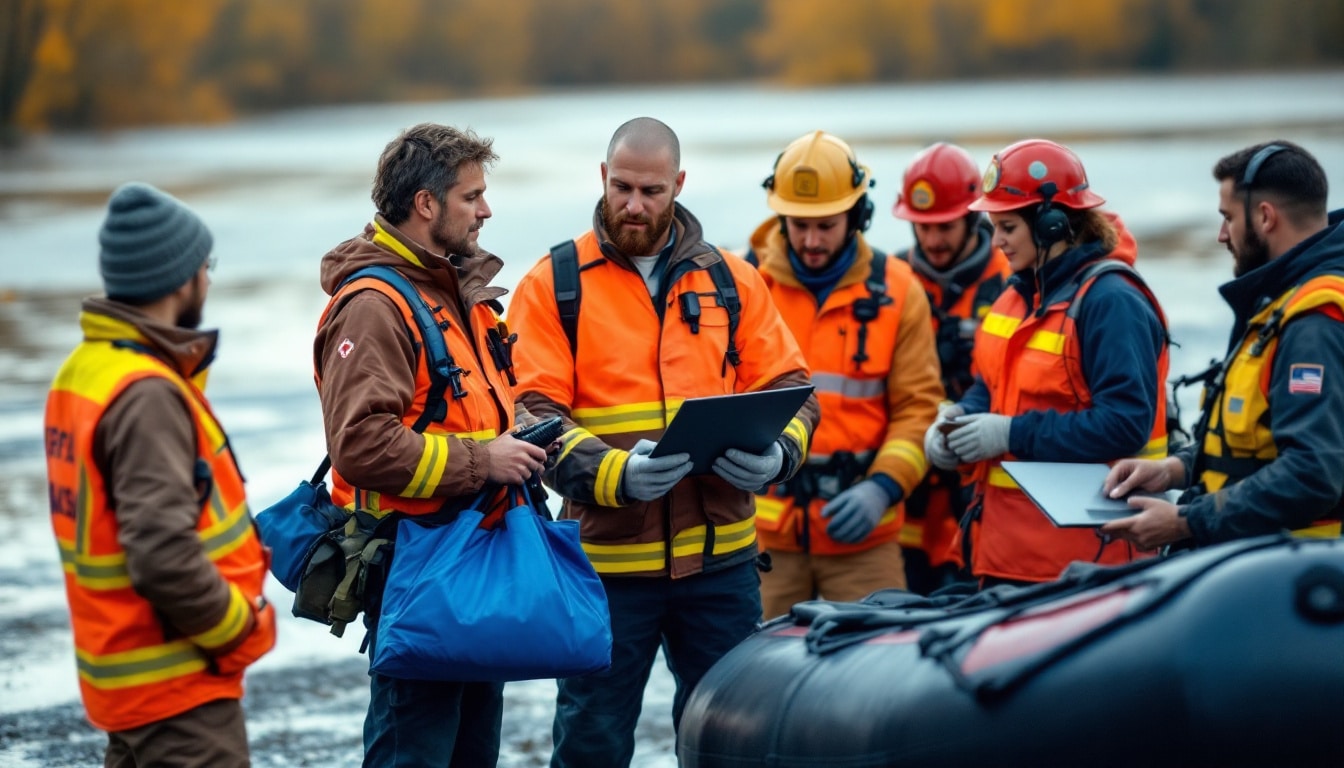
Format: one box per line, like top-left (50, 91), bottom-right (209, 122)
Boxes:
top-left (46, 299), bottom-right (276, 732)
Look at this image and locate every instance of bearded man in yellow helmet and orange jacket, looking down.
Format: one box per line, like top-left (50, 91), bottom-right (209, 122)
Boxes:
top-left (747, 130), bottom-right (943, 617)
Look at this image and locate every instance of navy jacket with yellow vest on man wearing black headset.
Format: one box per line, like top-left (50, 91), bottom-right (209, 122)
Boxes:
top-left (1183, 264), bottom-right (1344, 545)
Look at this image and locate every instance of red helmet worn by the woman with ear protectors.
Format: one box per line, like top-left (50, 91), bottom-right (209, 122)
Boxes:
top-left (970, 139), bottom-right (1106, 211)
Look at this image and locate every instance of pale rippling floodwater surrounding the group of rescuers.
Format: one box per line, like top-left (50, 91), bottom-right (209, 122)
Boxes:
top-left (0, 73), bottom-right (1344, 767)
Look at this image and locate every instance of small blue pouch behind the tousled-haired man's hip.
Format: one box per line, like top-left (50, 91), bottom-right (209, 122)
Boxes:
top-left (257, 480), bottom-right (348, 592)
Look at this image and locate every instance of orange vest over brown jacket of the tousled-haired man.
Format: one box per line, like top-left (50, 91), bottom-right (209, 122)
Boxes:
top-left (319, 268), bottom-right (513, 525)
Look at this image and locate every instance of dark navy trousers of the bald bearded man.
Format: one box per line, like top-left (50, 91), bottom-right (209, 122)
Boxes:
top-left (551, 560), bottom-right (761, 768)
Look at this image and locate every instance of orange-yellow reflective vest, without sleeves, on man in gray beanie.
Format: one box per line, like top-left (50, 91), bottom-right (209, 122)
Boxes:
top-left (46, 312), bottom-right (274, 730)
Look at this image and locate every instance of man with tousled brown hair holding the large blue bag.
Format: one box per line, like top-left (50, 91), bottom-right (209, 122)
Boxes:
top-left (313, 124), bottom-right (546, 767)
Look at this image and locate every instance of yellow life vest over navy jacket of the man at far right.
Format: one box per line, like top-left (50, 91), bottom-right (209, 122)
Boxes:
top-left (1198, 274), bottom-right (1344, 537)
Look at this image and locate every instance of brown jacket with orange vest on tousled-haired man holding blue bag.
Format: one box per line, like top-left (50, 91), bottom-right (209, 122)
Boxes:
top-left (313, 215), bottom-right (517, 525)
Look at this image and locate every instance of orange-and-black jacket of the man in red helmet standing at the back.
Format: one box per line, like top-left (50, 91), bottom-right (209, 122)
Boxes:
top-left (900, 221), bottom-right (1012, 568)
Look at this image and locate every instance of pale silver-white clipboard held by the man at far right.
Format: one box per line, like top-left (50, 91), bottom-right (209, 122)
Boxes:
top-left (1003, 461), bottom-right (1179, 529)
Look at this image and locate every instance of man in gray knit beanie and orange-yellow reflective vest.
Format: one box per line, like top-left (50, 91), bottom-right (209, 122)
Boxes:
top-left (46, 183), bottom-right (276, 768)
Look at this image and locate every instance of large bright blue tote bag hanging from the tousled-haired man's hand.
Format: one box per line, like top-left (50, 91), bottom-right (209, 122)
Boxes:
top-left (371, 488), bottom-right (612, 682)
